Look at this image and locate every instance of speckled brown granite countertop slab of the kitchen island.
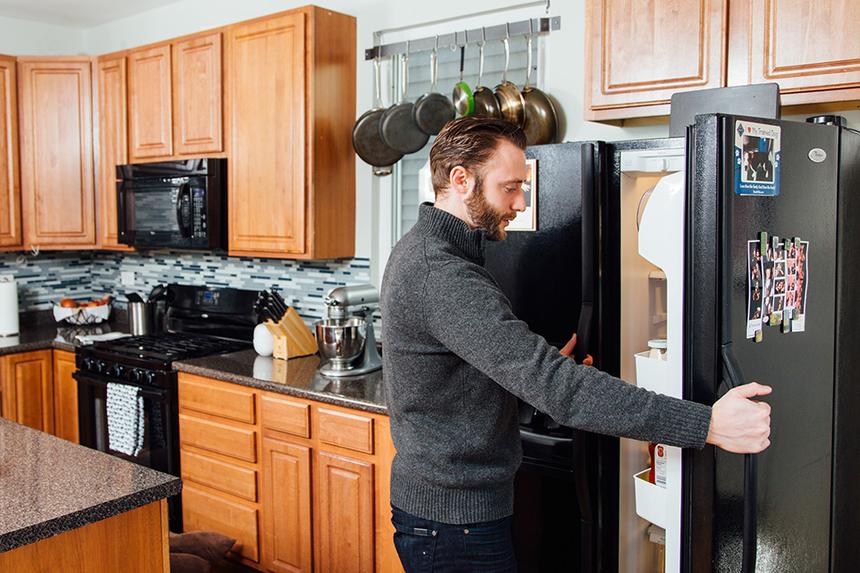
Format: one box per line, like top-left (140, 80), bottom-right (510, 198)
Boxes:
top-left (0, 418), bottom-right (182, 552)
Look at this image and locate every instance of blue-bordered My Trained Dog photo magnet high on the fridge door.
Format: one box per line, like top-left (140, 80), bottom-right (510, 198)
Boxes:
top-left (734, 119), bottom-right (781, 197)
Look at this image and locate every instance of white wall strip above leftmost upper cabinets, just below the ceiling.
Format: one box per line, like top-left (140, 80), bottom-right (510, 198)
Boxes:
top-left (0, 16), bottom-right (85, 56)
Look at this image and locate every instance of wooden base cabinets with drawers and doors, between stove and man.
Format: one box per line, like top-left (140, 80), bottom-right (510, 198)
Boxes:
top-left (179, 372), bottom-right (402, 573)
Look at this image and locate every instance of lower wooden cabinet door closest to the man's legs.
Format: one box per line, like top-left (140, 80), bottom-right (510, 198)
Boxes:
top-left (315, 451), bottom-right (375, 573)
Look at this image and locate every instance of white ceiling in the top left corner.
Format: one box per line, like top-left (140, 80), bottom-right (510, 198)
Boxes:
top-left (0, 0), bottom-right (179, 28)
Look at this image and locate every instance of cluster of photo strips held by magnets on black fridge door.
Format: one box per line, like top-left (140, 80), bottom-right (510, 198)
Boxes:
top-left (746, 233), bottom-right (809, 342)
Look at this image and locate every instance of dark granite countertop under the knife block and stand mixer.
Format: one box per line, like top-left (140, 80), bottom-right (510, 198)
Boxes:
top-left (173, 349), bottom-right (388, 414)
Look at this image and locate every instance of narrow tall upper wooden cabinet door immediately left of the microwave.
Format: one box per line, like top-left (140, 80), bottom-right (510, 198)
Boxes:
top-left (96, 56), bottom-right (128, 249)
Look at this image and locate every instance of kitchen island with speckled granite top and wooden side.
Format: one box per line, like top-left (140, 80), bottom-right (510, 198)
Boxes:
top-left (0, 419), bottom-right (181, 572)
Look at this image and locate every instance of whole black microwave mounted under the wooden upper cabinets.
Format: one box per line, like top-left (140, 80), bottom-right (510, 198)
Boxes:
top-left (116, 158), bottom-right (227, 249)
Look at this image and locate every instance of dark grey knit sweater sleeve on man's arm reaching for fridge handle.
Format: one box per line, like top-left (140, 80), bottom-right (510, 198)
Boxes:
top-left (424, 264), bottom-right (711, 448)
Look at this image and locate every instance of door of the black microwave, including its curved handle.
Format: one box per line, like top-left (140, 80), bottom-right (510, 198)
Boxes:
top-left (117, 177), bottom-right (196, 248)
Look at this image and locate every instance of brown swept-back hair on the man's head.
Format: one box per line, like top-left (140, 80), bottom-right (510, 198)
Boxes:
top-left (430, 116), bottom-right (526, 197)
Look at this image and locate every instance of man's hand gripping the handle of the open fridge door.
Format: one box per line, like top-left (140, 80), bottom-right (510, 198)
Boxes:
top-left (706, 382), bottom-right (773, 454)
